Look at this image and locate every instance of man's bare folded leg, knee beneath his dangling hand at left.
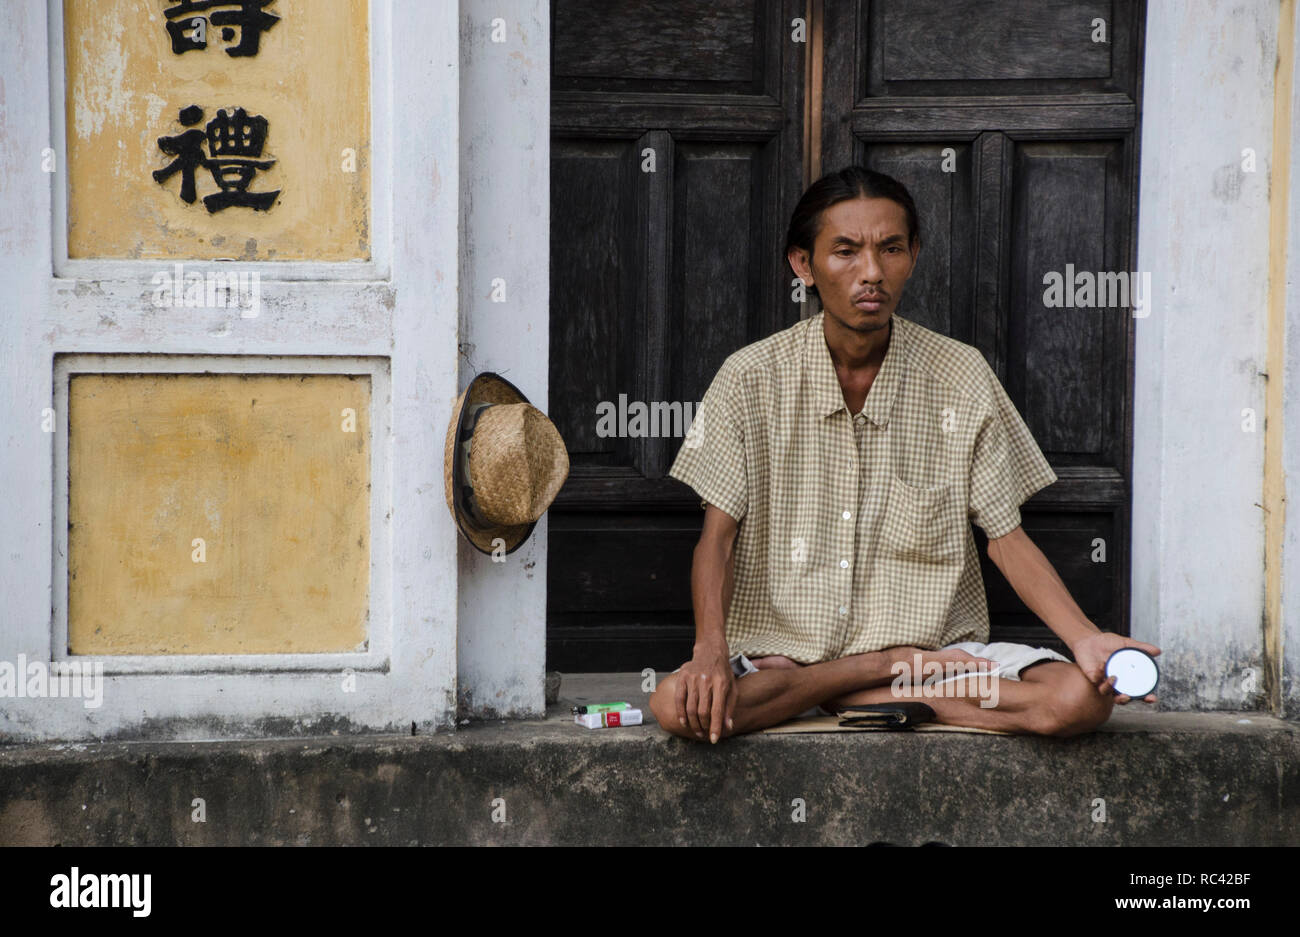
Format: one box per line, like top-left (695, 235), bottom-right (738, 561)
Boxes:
top-left (650, 647), bottom-right (976, 738)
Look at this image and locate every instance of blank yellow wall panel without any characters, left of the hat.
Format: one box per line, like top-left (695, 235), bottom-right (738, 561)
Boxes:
top-left (68, 374), bottom-right (371, 655)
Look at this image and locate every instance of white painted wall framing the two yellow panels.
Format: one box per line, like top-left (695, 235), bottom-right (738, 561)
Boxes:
top-left (0, 0), bottom-right (465, 739)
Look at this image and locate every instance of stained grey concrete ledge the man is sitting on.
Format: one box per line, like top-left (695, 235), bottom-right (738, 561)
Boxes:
top-left (0, 674), bottom-right (1300, 845)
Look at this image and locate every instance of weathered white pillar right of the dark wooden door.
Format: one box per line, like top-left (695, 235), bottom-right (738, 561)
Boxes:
top-left (1132, 0), bottom-right (1274, 708)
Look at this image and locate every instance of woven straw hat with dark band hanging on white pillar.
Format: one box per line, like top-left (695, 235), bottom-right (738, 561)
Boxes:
top-left (442, 372), bottom-right (568, 554)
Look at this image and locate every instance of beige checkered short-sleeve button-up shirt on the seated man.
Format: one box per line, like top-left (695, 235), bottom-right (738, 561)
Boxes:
top-left (670, 313), bottom-right (1057, 663)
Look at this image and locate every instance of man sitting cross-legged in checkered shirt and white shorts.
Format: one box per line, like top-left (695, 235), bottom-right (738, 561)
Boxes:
top-left (650, 166), bottom-right (1160, 742)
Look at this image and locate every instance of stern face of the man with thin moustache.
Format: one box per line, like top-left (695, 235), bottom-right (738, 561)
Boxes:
top-left (789, 199), bottom-right (920, 331)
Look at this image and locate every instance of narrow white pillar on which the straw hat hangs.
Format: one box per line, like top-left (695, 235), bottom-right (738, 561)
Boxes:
top-left (456, 0), bottom-right (551, 717)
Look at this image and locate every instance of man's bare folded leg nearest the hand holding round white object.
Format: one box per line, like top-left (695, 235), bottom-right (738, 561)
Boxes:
top-left (827, 660), bottom-right (1115, 738)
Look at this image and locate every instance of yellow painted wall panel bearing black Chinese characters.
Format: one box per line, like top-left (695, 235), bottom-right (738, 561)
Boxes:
top-left (64, 0), bottom-right (371, 261)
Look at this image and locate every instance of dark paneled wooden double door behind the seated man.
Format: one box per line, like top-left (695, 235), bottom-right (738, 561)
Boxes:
top-left (547, 0), bottom-right (1145, 672)
